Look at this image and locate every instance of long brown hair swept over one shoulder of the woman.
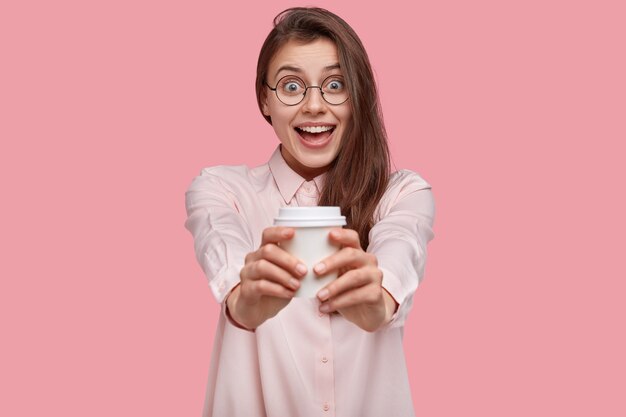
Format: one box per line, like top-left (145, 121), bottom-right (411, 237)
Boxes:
top-left (256, 7), bottom-right (390, 249)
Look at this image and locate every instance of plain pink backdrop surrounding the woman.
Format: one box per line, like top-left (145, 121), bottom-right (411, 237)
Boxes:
top-left (0, 0), bottom-right (626, 417)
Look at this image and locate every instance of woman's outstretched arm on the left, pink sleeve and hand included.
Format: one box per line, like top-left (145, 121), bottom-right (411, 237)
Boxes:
top-left (185, 170), bottom-right (306, 330)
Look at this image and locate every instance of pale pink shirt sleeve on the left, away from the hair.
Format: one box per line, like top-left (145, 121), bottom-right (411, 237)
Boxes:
top-left (185, 167), bottom-right (253, 303)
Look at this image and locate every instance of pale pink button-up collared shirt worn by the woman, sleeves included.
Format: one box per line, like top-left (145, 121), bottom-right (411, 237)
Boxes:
top-left (185, 147), bottom-right (434, 417)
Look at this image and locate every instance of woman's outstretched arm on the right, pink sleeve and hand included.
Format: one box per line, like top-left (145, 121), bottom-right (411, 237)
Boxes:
top-left (315, 171), bottom-right (434, 331)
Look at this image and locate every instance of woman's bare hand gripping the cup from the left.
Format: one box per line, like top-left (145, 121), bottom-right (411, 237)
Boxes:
top-left (226, 227), bottom-right (307, 330)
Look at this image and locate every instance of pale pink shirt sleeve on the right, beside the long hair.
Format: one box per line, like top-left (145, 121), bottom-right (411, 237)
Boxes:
top-left (368, 170), bottom-right (435, 327)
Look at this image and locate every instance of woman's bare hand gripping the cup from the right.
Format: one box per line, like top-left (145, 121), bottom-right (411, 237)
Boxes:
top-left (313, 229), bottom-right (398, 332)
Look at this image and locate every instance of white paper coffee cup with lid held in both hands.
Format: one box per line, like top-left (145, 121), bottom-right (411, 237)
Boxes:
top-left (274, 206), bottom-right (346, 298)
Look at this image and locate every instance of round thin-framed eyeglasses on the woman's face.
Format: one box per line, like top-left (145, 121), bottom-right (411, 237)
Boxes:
top-left (265, 75), bottom-right (348, 106)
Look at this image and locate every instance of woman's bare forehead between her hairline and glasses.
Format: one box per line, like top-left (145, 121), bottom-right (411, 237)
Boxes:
top-left (268, 38), bottom-right (339, 79)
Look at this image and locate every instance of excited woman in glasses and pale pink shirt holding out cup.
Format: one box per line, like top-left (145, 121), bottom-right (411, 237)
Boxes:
top-left (186, 8), bottom-right (434, 417)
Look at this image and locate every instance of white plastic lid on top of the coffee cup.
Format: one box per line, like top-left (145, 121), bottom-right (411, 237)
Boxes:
top-left (274, 206), bottom-right (346, 227)
